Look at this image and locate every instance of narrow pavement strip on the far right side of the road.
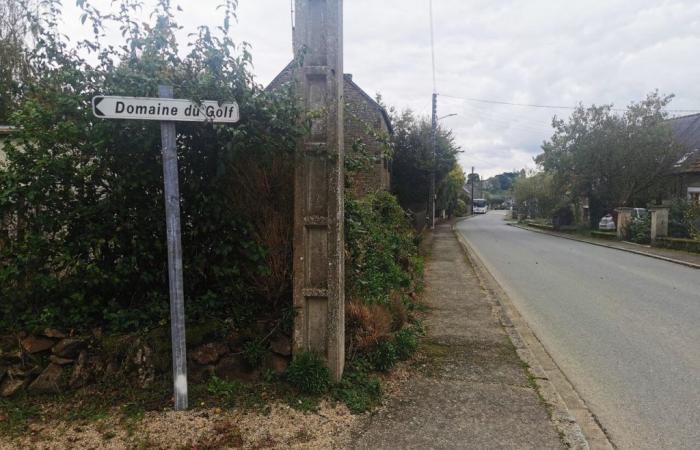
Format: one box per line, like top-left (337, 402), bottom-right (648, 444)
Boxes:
top-left (509, 222), bottom-right (700, 269)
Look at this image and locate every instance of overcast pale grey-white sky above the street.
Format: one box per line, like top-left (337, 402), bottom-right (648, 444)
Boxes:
top-left (58, 0), bottom-right (700, 177)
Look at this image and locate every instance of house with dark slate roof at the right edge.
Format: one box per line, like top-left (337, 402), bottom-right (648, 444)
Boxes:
top-left (667, 114), bottom-right (700, 203)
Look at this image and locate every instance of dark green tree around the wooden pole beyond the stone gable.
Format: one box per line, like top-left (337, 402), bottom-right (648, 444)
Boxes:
top-left (391, 110), bottom-right (459, 208)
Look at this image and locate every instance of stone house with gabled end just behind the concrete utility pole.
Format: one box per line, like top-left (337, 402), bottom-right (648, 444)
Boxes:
top-left (266, 62), bottom-right (393, 197)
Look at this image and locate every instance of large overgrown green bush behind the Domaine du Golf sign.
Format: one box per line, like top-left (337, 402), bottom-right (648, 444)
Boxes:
top-left (0, 1), bottom-right (303, 332)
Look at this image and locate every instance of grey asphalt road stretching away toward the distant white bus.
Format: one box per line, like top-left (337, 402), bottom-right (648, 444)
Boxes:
top-left (457, 211), bottom-right (700, 449)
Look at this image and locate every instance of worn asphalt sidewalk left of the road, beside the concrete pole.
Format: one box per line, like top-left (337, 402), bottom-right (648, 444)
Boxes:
top-left (352, 224), bottom-right (566, 450)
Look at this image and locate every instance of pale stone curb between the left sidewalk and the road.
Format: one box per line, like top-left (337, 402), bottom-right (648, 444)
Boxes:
top-left (452, 226), bottom-right (615, 450)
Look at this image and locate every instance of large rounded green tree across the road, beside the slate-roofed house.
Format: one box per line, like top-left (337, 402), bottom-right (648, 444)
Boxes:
top-left (536, 92), bottom-right (682, 225)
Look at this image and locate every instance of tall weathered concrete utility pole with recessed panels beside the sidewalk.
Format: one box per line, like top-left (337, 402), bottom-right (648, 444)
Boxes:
top-left (294, 0), bottom-right (345, 381)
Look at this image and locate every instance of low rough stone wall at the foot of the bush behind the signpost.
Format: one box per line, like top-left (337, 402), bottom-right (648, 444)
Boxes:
top-left (0, 324), bottom-right (292, 397)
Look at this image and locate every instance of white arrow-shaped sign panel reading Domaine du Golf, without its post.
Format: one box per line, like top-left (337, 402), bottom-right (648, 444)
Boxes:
top-left (92, 95), bottom-right (240, 123)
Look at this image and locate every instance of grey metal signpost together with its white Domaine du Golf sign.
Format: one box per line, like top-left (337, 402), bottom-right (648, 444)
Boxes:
top-left (92, 86), bottom-right (239, 411)
